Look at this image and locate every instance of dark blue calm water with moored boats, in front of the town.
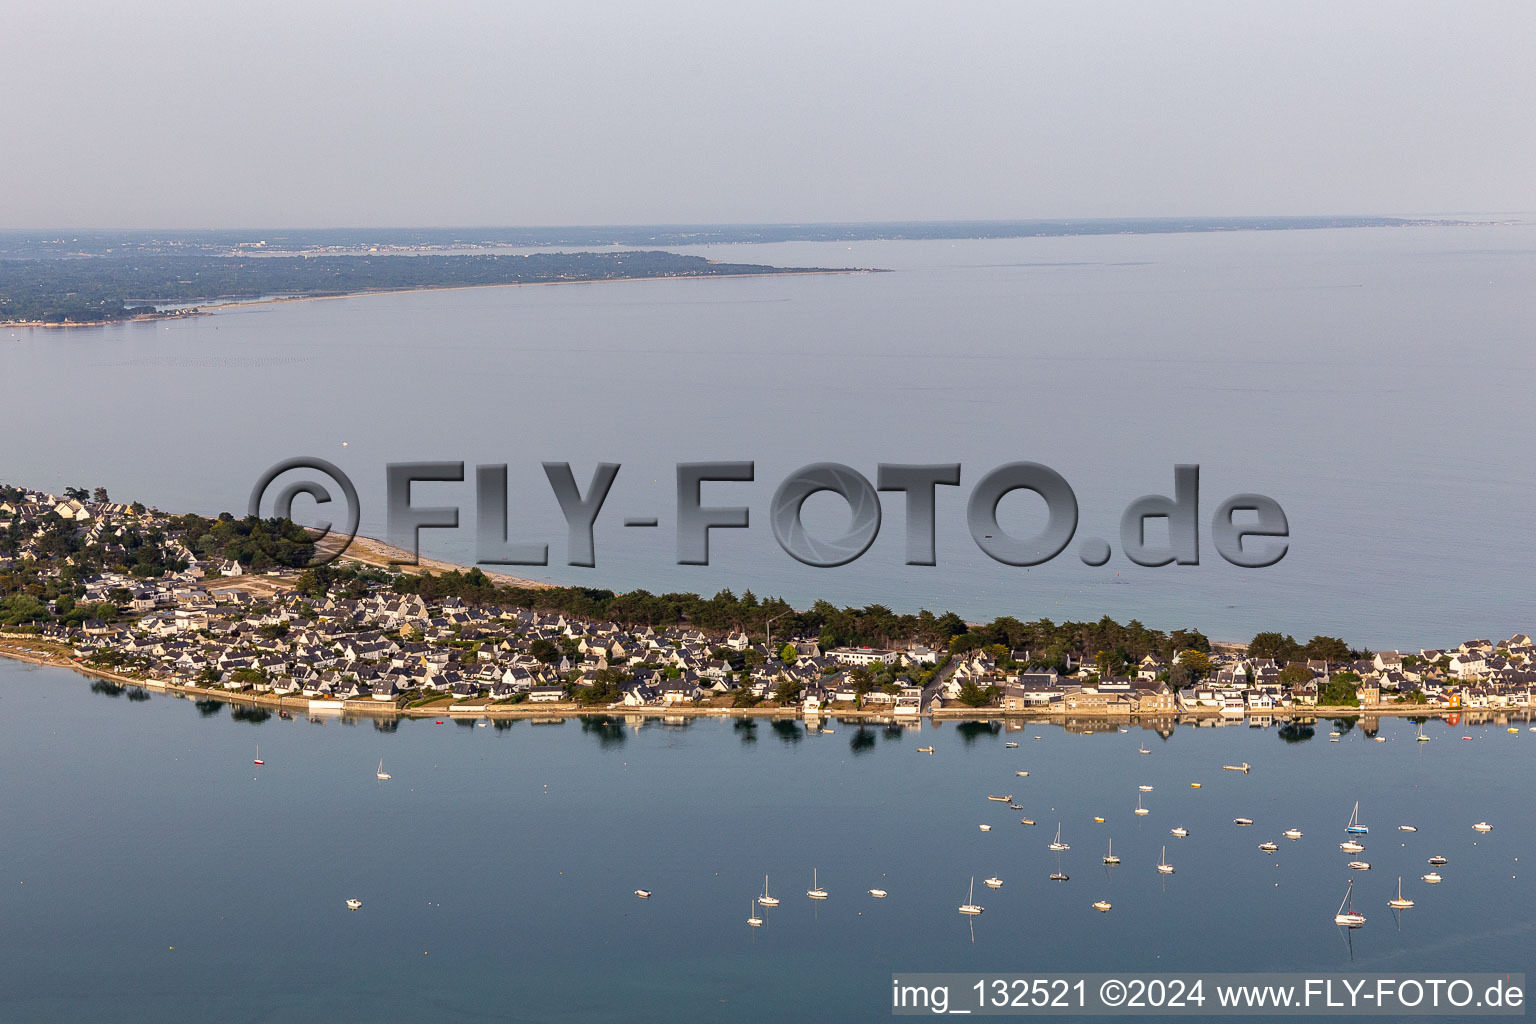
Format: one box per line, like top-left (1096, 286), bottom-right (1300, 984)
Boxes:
top-left (0, 662), bottom-right (1536, 1024)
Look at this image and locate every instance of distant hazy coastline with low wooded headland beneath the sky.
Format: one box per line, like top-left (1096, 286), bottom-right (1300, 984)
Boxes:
top-left (0, 216), bottom-right (1462, 327)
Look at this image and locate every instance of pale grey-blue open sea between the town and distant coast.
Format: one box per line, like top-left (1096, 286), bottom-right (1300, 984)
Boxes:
top-left (0, 224), bottom-right (1536, 648)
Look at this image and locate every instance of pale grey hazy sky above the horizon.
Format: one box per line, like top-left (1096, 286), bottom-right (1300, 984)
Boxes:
top-left (0, 0), bottom-right (1536, 227)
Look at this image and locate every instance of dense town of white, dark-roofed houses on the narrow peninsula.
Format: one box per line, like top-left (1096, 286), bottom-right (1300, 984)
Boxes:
top-left (0, 487), bottom-right (1536, 723)
